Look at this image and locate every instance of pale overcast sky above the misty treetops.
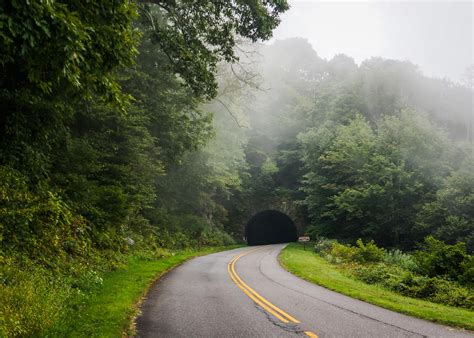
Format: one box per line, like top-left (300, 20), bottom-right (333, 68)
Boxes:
top-left (274, 0), bottom-right (474, 82)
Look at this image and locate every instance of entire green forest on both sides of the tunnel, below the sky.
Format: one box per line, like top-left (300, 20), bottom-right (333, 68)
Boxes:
top-left (0, 0), bottom-right (474, 334)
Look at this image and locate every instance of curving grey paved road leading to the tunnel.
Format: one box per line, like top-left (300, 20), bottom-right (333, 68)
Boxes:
top-left (137, 244), bottom-right (474, 337)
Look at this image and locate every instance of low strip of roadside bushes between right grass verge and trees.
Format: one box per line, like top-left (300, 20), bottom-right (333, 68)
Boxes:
top-left (314, 237), bottom-right (474, 309)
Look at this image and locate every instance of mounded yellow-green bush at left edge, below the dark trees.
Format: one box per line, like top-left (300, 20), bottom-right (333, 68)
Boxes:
top-left (0, 166), bottom-right (90, 268)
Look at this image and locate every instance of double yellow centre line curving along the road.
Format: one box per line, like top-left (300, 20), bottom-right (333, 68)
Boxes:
top-left (227, 248), bottom-right (318, 338)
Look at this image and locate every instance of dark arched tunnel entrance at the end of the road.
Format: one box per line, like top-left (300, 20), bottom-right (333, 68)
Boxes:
top-left (245, 210), bottom-right (297, 245)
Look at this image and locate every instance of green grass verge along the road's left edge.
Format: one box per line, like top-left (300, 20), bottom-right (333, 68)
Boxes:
top-left (48, 245), bottom-right (243, 337)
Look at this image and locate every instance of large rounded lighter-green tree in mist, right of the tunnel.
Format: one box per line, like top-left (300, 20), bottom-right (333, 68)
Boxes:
top-left (302, 111), bottom-right (449, 246)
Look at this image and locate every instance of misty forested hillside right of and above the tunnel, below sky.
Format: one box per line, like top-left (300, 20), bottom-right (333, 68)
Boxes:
top-left (228, 39), bottom-right (474, 251)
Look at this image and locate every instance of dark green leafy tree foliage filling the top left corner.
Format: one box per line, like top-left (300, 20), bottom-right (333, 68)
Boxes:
top-left (0, 0), bottom-right (139, 179)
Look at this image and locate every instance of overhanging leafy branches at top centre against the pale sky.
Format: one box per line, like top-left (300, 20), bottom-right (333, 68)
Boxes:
top-left (142, 0), bottom-right (289, 98)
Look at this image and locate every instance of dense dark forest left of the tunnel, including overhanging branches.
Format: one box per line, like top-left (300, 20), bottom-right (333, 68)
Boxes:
top-left (0, 1), bottom-right (287, 265)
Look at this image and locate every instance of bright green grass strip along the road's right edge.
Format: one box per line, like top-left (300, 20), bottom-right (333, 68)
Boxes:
top-left (280, 243), bottom-right (474, 330)
